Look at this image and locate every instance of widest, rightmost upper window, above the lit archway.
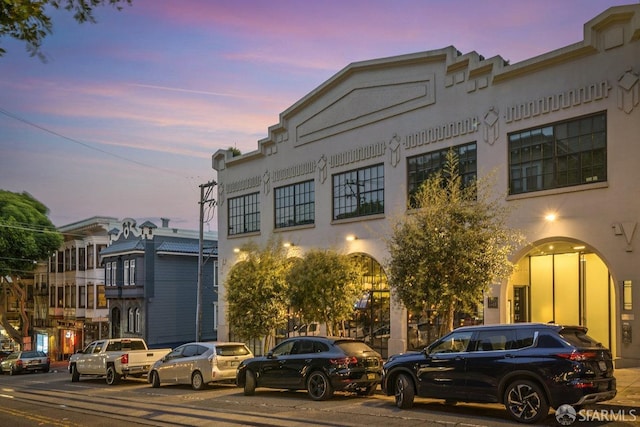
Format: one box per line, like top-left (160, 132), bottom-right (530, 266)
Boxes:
top-left (509, 113), bottom-right (607, 194)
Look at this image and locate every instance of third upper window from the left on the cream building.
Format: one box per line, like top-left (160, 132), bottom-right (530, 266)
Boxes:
top-left (333, 164), bottom-right (384, 219)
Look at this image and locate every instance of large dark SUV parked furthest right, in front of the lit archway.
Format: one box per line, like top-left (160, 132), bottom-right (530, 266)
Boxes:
top-left (382, 323), bottom-right (616, 423)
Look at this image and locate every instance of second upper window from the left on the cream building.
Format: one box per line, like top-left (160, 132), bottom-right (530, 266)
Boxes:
top-left (273, 180), bottom-right (316, 228)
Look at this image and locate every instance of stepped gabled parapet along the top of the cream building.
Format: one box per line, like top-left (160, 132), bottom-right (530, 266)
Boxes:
top-left (212, 4), bottom-right (640, 169)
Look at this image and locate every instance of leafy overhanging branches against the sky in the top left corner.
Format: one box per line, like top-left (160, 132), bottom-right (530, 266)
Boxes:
top-left (0, 0), bottom-right (132, 59)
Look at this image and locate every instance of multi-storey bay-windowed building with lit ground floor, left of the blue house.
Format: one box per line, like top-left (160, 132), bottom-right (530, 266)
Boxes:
top-left (33, 216), bottom-right (118, 360)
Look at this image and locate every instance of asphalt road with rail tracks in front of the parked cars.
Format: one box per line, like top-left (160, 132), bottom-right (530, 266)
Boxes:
top-left (0, 369), bottom-right (640, 427)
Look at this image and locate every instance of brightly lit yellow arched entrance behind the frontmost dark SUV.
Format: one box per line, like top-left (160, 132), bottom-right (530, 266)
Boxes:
top-left (507, 239), bottom-right (615, 351)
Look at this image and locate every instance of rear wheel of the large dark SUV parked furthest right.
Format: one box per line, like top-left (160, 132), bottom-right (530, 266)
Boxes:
top-left (504, 380), bottom-right (549, 424)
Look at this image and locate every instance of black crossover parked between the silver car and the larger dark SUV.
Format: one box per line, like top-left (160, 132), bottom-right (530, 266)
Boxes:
top-left (236, 337), bottom-right (382, 400)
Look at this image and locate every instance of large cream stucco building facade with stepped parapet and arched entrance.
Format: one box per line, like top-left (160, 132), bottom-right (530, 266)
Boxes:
top-left (213, 4), bottom-right (640, 366)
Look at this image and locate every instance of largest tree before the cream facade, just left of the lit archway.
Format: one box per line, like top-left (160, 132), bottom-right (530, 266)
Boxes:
top-left (387, 150), bottom-right (523, 335)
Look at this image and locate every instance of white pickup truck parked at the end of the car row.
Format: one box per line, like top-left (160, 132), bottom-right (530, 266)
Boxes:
top-left (69, 338), bottom-right (171, 385)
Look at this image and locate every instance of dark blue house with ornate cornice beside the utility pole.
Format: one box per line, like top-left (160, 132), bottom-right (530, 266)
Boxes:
top-left (100, 218), bottom-right (218, 347)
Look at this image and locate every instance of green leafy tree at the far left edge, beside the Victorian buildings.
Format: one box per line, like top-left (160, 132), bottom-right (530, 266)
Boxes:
top-left (0, 190), bottom-right (63, 343)
